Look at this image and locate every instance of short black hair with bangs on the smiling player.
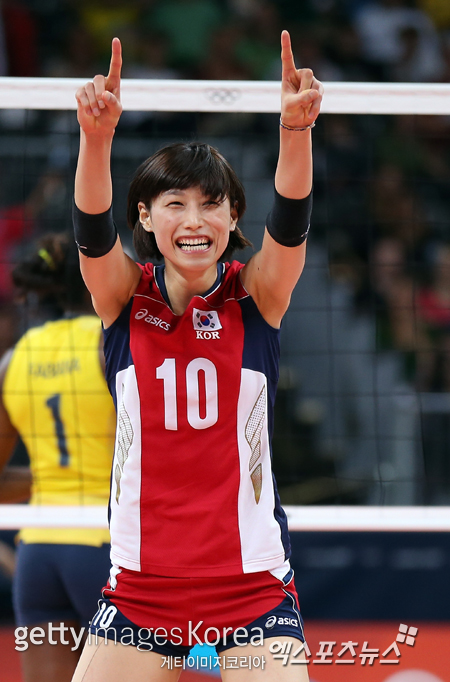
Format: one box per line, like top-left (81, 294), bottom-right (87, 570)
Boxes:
top-left (127, 142), bottom-right (252, 260)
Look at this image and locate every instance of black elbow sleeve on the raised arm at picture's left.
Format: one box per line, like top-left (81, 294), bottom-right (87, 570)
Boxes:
top-left (72, 202), bottom-right (117, 258)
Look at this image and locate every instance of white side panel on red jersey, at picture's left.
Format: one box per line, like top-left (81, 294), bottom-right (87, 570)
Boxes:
top-left (110, 365), bottom-right (141, 571)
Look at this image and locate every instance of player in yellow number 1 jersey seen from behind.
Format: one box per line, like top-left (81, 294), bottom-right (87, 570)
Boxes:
top-left (0, 234), bottom-right (115, 682)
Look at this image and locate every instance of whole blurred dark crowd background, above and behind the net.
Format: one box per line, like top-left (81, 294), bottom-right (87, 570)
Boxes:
top-left (0, 0), bottom-right (450, 505)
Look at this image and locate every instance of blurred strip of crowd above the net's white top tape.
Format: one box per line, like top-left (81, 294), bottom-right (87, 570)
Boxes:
top-left (0, 0), bottom-right (450, 82)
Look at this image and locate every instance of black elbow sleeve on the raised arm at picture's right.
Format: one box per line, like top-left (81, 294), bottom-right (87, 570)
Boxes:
top-left (267, 190), bottom-right (312, 247)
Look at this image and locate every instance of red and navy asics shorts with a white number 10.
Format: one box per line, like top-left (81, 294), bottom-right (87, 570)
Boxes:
top-left (90, 568), bottom-right (304, 657)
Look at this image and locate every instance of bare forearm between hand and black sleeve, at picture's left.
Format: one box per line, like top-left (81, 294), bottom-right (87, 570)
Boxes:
top-left (75, 130), bottom-right (113, 214)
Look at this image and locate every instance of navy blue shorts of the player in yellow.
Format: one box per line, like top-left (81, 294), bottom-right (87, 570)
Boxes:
top-left (13, 542), bottom-right (111, 628)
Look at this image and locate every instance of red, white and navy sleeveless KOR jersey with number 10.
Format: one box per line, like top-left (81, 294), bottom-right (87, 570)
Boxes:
top-left (105, 262), bottom-right (290, 577)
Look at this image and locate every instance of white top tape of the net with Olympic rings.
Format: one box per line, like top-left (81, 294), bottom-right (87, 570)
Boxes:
top-left (0, 78), bottom-right (450, 115)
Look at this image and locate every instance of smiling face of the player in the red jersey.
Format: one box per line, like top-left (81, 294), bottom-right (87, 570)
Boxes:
top-left (138, 187), bottom-right (238, 272)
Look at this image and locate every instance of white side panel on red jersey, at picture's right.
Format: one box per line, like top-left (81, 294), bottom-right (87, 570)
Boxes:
top-left (237, 369), bottom-right (285, 573)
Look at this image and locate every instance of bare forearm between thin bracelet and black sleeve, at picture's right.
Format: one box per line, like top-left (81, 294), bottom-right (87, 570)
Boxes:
top-left (275, 126), bottom-right (313, 199)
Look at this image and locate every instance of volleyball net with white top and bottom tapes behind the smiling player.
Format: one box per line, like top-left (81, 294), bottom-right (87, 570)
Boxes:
top-left (0, 78), bottom-right (450, 531)
